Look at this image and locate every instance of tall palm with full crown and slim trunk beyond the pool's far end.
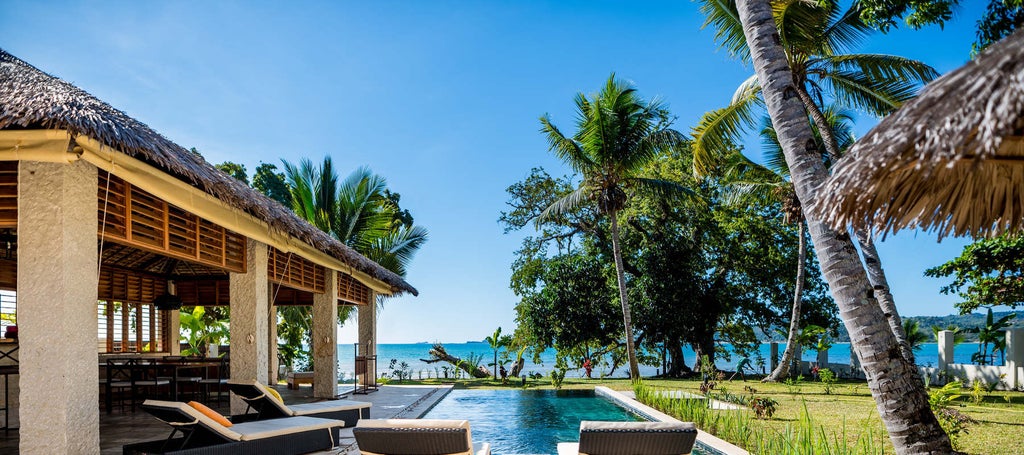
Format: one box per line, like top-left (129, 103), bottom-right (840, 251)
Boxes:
top-left (537, 74), bottom-right (687, 379)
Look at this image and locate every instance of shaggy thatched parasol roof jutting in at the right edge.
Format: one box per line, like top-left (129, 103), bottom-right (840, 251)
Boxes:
top-left (815, 30), bottom-right (1024, 238)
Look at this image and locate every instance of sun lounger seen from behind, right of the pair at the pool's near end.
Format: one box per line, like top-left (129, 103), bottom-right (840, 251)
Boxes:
top-left (558, 420), bottom-right (697, 455)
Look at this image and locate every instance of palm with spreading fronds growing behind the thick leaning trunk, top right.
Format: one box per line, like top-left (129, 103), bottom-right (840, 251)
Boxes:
top-left (693, 0), bottom-right (937, 363)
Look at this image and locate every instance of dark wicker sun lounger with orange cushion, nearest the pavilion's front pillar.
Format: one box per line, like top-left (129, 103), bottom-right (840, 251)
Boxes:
top-left (124, 400), bottom-right (341, 455)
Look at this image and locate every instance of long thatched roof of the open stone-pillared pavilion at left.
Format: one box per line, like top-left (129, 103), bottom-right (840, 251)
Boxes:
top-left (0, 49), bottom-right (418, 295)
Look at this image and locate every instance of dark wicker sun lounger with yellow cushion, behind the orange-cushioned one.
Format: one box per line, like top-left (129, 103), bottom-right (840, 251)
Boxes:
top-left (227, 381), bottom-right (371, 426)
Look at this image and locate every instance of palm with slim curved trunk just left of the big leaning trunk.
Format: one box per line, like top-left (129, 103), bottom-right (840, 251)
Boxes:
top-left (723, 106), bottom-right (854, 382)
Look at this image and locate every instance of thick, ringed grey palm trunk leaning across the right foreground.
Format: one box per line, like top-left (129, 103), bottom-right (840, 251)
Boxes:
top-left (736, 0), bottom-right (952, 454)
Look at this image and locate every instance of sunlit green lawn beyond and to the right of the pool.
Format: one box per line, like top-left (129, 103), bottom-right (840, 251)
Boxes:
top-left (392, 377), bottom-right (1024, 455)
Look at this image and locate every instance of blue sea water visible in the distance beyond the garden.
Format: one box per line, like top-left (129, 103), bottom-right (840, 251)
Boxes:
top-left (338, 342), bottom-right (978, 380)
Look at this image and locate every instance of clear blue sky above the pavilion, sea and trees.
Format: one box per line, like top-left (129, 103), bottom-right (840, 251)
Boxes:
top-left (0, 0), bottom-right (980, 342)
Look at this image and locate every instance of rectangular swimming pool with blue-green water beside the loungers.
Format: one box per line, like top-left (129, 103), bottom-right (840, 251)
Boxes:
top-left (423, 389), bottom-right (705, 455)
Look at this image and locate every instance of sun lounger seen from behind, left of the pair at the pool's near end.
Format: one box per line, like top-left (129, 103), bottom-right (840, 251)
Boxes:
top-left (352, 419), bottom-right (490, 455)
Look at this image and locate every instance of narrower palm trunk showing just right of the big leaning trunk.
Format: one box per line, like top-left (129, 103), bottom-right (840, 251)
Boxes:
top-left (796, 84), bottom-right (916, 365)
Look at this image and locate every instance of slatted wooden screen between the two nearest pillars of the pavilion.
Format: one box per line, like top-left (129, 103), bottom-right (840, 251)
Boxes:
top-left (97, 171), bottom-right (246, 273)
